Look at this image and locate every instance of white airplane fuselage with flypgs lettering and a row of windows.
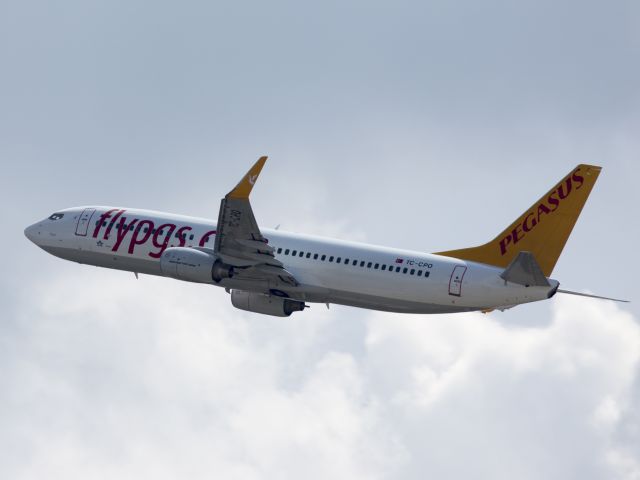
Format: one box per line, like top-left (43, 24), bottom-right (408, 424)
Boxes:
top-left (25, 207), bottom-right (558, 313)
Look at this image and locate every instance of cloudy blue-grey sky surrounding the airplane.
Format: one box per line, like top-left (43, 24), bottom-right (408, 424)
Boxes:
top-left (0, 0), bottom-right (640, 480)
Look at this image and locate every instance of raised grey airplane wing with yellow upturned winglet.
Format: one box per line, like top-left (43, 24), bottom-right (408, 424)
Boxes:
top-left (213, 157), bottom-right (299, 286)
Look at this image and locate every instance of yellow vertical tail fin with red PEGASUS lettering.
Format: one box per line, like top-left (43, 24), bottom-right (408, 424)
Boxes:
top-left (436, 165), bottom-right (601, 277)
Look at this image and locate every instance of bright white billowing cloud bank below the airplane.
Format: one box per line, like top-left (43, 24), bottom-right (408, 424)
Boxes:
top-left (0, 269), bottom-right (640, 479)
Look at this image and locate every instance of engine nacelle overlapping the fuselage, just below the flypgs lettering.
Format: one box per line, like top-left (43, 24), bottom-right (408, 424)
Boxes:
top-left (160, 247), bottom-right (233, 283)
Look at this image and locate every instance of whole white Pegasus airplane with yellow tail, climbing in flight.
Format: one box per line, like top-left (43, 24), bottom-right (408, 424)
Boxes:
top-left (24, 157), bottom-right (625, 317)
